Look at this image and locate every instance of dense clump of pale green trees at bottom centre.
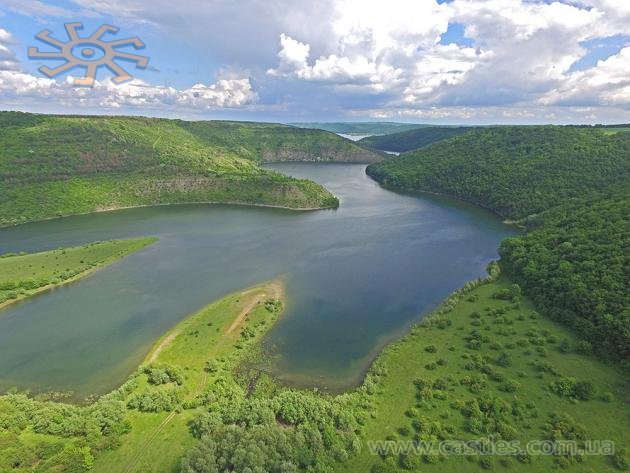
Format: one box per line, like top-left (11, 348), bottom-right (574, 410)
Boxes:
top-left (181, 377), bottom-right (360, 473)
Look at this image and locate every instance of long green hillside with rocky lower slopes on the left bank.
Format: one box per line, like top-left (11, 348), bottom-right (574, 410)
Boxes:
top-left (0, 112), bottom-right (379, 226)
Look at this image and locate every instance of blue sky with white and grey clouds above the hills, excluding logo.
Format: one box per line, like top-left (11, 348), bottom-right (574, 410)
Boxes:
top-left (0, 0), bottom-right (630, 124)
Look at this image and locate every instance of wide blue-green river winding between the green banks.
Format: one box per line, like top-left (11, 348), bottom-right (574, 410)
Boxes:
top-left (0, 164), bottom-right (513, 396)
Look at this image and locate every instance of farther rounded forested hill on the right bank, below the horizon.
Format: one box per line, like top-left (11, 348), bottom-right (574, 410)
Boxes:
top-left (367, 126), bottom-right (630, 219)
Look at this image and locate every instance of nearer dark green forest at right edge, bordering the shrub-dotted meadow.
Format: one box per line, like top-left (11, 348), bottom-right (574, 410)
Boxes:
top-left (499, 194), bottom-right (630, 362)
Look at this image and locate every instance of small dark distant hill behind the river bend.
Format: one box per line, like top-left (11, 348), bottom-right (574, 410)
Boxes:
top-left (357, 126), bottom-right (473, 153)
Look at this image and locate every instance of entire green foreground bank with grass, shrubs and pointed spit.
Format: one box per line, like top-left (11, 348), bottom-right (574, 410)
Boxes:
top-left (0, 273), bottom-right (630, 473)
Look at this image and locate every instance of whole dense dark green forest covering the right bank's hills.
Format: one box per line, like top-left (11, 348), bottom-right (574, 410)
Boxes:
top-left (367, 126), bottom-right (630, 362)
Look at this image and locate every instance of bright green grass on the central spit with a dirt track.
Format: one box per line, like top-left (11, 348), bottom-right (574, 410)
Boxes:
top-left (94, 281), bottom-right (282, 472)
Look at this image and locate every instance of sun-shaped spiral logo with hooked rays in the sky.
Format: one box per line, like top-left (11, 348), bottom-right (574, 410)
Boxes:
top-left (28, 22), bottom-right (149, 87)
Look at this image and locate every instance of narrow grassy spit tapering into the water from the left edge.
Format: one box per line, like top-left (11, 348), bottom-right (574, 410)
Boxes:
top-left (0, 237), bottom-right (157, 308)
